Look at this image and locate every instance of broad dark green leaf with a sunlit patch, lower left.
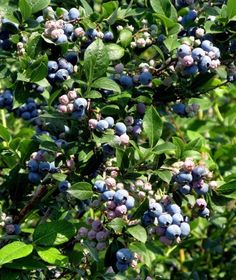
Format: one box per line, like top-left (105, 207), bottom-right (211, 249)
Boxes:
top-left (33, 221), bottom-right (75, 246)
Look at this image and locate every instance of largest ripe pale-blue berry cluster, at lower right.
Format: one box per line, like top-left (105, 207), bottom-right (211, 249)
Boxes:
top-left (141, 199), bottom-right (190, 245)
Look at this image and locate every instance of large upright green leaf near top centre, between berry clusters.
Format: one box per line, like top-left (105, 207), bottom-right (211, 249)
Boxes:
top-left (84, 39), bottom-right (109, 82)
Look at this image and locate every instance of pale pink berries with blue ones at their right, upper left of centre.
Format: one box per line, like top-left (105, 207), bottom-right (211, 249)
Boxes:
top-left (58, 90), bottom-right (88, 119)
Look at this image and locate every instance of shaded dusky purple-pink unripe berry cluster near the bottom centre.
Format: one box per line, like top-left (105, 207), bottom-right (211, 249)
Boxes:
top-left (77, 219), bottom-right (110, 251)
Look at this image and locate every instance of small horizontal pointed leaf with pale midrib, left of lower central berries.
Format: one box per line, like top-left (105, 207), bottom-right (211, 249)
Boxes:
top-left (67, 182), bottom-right (93, 200)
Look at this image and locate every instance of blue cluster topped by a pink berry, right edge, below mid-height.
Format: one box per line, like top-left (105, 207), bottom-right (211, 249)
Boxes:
top-left (172, 159), bottom-right (209, 195)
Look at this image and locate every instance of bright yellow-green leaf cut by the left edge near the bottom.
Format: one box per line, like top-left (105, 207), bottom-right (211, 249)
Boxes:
top-left (0, 241), bottom-right (33, 266)
